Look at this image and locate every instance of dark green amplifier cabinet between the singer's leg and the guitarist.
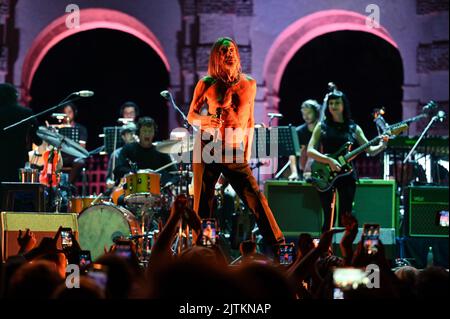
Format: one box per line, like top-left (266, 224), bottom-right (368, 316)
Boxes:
top-left (264, 180), bottom-right (323, 236)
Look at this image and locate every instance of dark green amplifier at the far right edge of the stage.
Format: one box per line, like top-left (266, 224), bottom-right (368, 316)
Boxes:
top-left (407, 186), bottom-right (449, 238)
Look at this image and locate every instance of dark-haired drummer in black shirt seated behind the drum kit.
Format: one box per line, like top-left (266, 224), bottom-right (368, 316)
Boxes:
top-left (114, 117), bottom-right (177, 185)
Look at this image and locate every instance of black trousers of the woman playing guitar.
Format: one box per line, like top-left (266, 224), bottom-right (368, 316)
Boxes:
top-left (318, 175), bottom-right (356, 233)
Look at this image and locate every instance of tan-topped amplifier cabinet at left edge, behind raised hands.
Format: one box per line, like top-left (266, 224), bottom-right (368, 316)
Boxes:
top-left (0, 212), bottom-right (78, 261)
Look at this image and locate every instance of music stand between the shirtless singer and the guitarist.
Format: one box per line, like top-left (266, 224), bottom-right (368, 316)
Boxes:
top-left (252, 125), bottom-right (300, 184)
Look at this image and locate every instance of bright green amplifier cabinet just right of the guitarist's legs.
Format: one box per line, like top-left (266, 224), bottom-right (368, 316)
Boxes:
top-left (344, 178), bottom-right (397, 229)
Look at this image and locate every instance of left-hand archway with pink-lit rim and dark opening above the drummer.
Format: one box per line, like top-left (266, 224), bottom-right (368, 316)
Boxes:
top-left (21, 9), bottom-right (170, 148)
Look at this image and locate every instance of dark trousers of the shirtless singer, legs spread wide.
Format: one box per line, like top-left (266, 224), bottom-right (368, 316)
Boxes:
top-left (193, 163), bottom-right (284, 245)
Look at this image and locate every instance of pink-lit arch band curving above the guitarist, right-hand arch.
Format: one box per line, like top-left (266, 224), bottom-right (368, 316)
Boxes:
top-left (263, 10), bottom-right (398, 112)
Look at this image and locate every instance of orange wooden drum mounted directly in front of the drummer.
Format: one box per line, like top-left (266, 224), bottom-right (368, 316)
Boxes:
top-left (124, 170), bottom-right (161, 203)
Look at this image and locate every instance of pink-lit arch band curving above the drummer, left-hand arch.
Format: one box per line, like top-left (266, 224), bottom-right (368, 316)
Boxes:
top-left (21, 8), bottom-right (170, 105)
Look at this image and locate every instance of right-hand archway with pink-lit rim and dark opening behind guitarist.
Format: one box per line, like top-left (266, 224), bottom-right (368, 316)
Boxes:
top-left (263, 10), bottom-right (403, 177)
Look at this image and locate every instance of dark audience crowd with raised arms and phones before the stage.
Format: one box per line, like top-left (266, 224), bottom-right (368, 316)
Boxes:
top-left (1, 195), bottom-right (448, 300)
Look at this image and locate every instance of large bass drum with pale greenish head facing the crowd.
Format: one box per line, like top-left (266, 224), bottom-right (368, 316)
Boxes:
top-left (78, 203), bottom-right (141, 260)
